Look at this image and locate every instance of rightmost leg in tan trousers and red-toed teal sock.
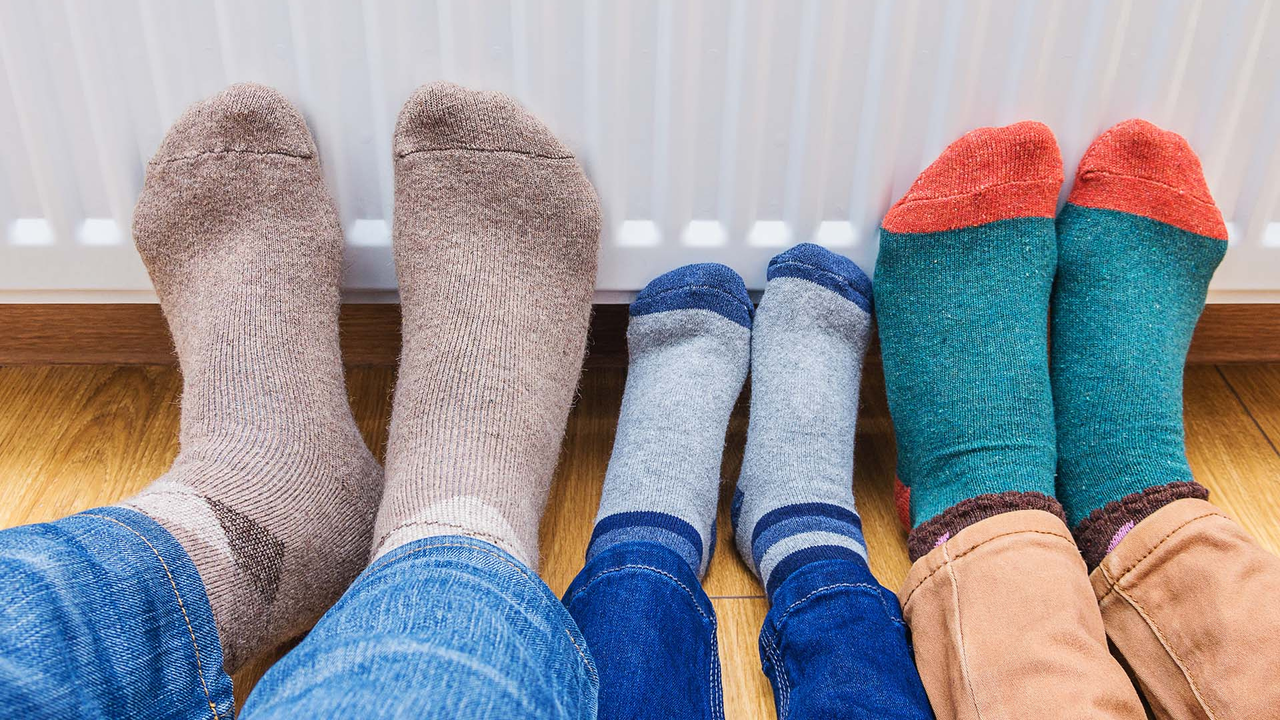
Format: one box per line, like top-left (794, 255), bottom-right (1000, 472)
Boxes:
top-left (1053, 120), bottom-right (1280, 719)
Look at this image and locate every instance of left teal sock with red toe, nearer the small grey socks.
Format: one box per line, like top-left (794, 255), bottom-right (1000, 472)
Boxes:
top-left (876, 123), bottom-right (1062, 560)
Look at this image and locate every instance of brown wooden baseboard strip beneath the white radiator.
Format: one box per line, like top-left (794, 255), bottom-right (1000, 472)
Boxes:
top-left (0, 304), bottom-right (1280, 366)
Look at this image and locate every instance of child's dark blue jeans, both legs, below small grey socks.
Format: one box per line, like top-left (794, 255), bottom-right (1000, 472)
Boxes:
top-left (564, 542), bottom-right (933, 720)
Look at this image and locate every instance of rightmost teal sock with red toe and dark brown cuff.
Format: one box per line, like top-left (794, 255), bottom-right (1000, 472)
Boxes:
top-left (1052, 120), bottom-right (1226, 568)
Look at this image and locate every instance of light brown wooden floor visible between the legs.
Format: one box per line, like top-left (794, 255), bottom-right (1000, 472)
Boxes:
top-left (0, 365), bottom-right (1280, 720)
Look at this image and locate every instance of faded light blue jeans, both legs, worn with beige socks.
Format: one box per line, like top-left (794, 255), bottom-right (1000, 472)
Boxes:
top-left (0, 507), bottom-right (599, 720)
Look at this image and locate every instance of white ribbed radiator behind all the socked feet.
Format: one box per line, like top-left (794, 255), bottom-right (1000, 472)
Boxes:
top-left (0, 0), bottom-right (1280, 301)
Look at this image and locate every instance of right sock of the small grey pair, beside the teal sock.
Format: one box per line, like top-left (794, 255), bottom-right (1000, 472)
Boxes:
top-left (732, 245), bottom-right (872, 597)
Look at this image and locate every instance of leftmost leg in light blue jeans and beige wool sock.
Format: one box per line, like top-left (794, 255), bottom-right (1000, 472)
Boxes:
top-left (0, 85), bottom-right (381, 717)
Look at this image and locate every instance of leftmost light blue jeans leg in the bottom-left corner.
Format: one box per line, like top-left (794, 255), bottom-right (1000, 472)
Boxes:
top-left (0, 507), bottom-right (234, 720)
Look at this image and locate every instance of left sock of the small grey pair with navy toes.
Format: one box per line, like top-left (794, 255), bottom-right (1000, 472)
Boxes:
top-left (586, 264), bottom-right (753, 575)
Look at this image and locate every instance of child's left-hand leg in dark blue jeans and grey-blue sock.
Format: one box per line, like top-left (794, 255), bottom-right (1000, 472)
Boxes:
top-left (564, 264), bottom-right (753, 720)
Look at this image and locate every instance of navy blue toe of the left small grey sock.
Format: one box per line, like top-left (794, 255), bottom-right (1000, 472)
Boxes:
top-left (631, 263), bottom-right (755, 328)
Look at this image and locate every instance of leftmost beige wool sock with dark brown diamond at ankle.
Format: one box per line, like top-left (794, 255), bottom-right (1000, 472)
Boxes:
top-left (123, 85), bottom-right (383, 671)
